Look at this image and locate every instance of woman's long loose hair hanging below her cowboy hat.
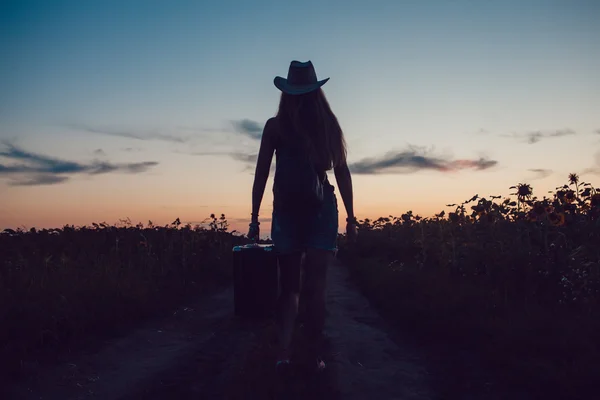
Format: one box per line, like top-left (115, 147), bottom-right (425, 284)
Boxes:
top-left (277, 88), bottom-right (346, 170)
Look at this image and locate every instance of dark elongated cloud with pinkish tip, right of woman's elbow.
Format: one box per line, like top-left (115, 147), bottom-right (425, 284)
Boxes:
top-left (349, 148), bottom-right (498, 175)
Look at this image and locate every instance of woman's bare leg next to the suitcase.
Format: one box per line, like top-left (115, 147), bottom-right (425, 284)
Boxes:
top-left (277, 252), bottom-right (302, 360)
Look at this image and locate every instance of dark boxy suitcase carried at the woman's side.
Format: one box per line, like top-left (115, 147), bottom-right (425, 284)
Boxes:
top-left (233, 244), bottom-right (279, 319)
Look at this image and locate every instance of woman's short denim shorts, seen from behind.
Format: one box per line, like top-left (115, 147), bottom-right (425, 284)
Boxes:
top-left (271, 184), bottom-right (339, 253)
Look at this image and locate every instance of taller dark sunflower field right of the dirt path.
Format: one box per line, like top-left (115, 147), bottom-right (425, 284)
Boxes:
top-left (339, 174), bottom-right (600, 396)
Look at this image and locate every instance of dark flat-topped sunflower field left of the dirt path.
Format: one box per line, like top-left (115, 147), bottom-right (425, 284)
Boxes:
top-left (0, 215), bottom-right (245, 377)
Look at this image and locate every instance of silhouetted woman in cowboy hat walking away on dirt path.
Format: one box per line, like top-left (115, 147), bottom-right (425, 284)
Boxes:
top-left (248, 61), bottom-right (357, 369)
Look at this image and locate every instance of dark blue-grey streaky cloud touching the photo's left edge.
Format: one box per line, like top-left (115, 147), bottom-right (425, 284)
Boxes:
top-left (0, 142), bottom-right (158, 186)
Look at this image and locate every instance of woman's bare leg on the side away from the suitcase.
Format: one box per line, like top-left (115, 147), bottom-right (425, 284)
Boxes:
top-left (303, 248), bottom-right (334, 350)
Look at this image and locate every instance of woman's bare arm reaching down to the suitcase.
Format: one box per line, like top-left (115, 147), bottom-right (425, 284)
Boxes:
top-left (252, 118), bottom-right (277, 222)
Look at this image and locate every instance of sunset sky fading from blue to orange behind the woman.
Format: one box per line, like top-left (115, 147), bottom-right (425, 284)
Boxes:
top-left (0, 0), bottom-right (600, 234)
